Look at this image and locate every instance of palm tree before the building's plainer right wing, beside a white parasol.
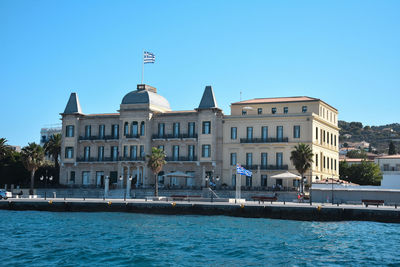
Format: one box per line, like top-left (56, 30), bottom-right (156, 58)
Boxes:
top-left (290, 143), bottom-right (314, 193)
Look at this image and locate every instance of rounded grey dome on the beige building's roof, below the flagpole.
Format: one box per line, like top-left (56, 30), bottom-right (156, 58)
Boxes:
top-left (121, 90), bottom-right (171, 110)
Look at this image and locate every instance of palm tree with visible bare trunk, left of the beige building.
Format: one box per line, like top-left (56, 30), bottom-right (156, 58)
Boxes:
top-left (22, 143), bottom-right (44, 194)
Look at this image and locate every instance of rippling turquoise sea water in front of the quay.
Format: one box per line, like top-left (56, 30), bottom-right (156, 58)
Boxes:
top-left (0, 211), bottom-right (400, 266)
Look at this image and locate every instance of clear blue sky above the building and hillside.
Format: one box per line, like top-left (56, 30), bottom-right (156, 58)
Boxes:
top-left (0, 0), bottom-right (400, 146)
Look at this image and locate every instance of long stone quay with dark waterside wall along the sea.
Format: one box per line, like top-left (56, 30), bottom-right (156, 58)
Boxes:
top-left (0, 198), bottom-right (400, 223)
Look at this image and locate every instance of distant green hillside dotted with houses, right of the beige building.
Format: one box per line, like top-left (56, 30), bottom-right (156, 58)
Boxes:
top-left (339, 121), bottom-right (400, 153)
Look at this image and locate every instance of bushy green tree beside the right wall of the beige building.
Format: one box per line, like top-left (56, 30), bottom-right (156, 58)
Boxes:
top-left (339, 160), bottom-right (382, 185)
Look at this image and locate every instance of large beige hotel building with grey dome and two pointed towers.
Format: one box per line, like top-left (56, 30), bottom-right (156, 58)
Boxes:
top-left (60, 84), bottom-right (339, 191)
